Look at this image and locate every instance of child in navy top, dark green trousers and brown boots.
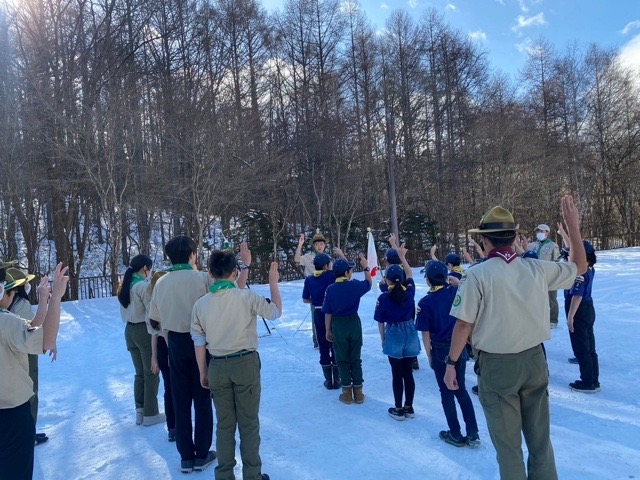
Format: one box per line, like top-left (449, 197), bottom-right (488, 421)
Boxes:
top-left (322, 253), bottom-right (373, 404)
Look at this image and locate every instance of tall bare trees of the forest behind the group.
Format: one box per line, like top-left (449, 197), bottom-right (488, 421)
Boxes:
top-left (0, 0), bottom-right (640, 298)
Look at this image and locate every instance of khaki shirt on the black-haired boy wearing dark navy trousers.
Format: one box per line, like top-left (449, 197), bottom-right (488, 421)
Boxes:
top-left (149, 270), bottom-right (213, 333)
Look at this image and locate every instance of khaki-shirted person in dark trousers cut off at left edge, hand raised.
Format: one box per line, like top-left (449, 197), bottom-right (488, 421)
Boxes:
top-left (0, 263), bottom-right (69, 480)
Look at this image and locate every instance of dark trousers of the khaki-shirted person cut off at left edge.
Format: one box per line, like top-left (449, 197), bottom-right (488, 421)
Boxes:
top-left (0, 402), bottom-right (36, 480)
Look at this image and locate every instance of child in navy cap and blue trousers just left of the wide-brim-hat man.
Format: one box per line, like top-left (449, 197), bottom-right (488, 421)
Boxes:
top-left (416, 260), bottom-right (480, 447)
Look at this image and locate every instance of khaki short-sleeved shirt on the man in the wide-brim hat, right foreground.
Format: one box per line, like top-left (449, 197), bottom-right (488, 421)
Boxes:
top-left (450, 258), bottom-right (577, 353)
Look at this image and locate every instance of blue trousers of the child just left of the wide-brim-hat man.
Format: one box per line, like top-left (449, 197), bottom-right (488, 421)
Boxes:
top-left (431, 340), bottom-right (478, 436)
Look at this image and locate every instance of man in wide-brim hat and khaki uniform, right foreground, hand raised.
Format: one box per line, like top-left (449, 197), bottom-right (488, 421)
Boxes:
top-left (445, 196), bottom-right (587, 480)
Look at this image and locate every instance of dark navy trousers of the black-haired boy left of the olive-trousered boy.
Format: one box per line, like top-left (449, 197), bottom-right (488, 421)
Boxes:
top-left (169, 332), bottom-right (213, 460)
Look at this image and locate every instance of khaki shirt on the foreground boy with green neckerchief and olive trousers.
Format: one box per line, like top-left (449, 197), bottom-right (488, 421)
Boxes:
top-left (191, 288), bottom-right (280, 357)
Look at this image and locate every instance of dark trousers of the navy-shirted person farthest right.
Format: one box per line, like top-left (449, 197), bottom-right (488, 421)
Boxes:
top-left (564, 301), bottom-right (600, 386)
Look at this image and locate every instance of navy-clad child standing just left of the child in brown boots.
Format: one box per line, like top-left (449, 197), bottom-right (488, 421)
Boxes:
top-left (302, 253), bottom-right (340, 390)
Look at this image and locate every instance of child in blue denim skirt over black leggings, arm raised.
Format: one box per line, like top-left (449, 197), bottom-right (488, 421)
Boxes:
top-left (373, 245), bottom-right (420, 420)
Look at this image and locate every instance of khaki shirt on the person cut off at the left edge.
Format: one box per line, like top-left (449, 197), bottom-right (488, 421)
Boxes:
top-left (0, 310), bottom-right (44, 409)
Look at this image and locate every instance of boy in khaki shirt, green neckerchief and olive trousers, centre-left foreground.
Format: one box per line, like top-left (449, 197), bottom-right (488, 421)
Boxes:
top-left (191, 243), bottom-right (282, 480)
